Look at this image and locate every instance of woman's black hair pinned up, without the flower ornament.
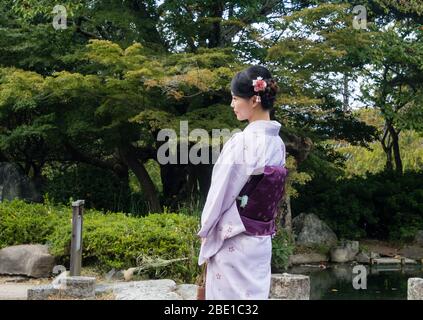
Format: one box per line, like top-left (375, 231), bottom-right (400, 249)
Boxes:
top-left (231, 66), bottom-right (279, 111)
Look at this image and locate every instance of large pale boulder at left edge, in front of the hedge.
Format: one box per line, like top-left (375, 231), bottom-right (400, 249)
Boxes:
top-left (0, 244), bottom-right (55, 278)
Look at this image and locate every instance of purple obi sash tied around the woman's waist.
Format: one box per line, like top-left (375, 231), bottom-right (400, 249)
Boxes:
top-left (236, 166), bottom-right (288, 236)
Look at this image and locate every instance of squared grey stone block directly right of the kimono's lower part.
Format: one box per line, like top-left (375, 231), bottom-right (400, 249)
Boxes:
top-left (269, 273), bottom-right (310, 300)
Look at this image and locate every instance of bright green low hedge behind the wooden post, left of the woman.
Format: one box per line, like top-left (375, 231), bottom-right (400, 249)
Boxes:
top-left (0, 200), bottom-right (200, 283)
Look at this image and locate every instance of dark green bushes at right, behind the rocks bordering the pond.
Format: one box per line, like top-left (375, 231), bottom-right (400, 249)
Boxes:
top-left (292, 171), bottom-right (423, 241)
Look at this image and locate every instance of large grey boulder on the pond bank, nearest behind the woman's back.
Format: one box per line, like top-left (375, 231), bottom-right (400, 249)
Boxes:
top-left (292, 213), bottom-right (338, 246)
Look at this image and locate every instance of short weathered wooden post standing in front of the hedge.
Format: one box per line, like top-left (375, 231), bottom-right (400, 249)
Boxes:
top-left (70, 200), bottom-right (85, 276)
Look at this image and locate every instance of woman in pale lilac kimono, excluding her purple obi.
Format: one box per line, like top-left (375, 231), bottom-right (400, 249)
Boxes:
top-left (198, 66), bottom-right (285, 300)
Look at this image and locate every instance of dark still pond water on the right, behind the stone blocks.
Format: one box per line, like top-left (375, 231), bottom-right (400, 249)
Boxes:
top-left (285, 264), bottom-right (423, 300)
